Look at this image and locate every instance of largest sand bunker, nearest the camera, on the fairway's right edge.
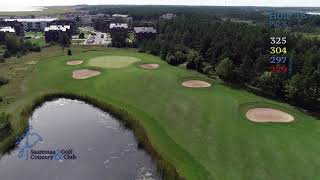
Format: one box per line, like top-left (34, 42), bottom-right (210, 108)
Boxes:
top-left (246, 108), bottom-right (294, 122)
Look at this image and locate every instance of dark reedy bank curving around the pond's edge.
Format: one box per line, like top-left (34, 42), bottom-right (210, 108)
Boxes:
top-left (5, 93), bottom-right (185, 180)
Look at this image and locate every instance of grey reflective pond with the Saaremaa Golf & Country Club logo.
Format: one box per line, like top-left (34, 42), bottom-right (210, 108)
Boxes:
top-left (0, 98), bottom-right (161, 180)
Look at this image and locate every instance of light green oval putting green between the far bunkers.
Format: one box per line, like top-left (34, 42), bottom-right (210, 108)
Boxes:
top-left (89, 56), bottom-right (140, 68)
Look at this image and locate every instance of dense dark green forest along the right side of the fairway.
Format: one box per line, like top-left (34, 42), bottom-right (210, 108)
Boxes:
top-left (138, 15), bottom-right (320, 112)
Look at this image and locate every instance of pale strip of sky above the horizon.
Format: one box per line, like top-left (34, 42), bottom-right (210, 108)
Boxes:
top-left (0, 0), bottom-right (320, 10)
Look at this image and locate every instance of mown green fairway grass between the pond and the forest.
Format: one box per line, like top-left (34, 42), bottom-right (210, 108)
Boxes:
top-left (0, 46), bottom-right (320, 180)
